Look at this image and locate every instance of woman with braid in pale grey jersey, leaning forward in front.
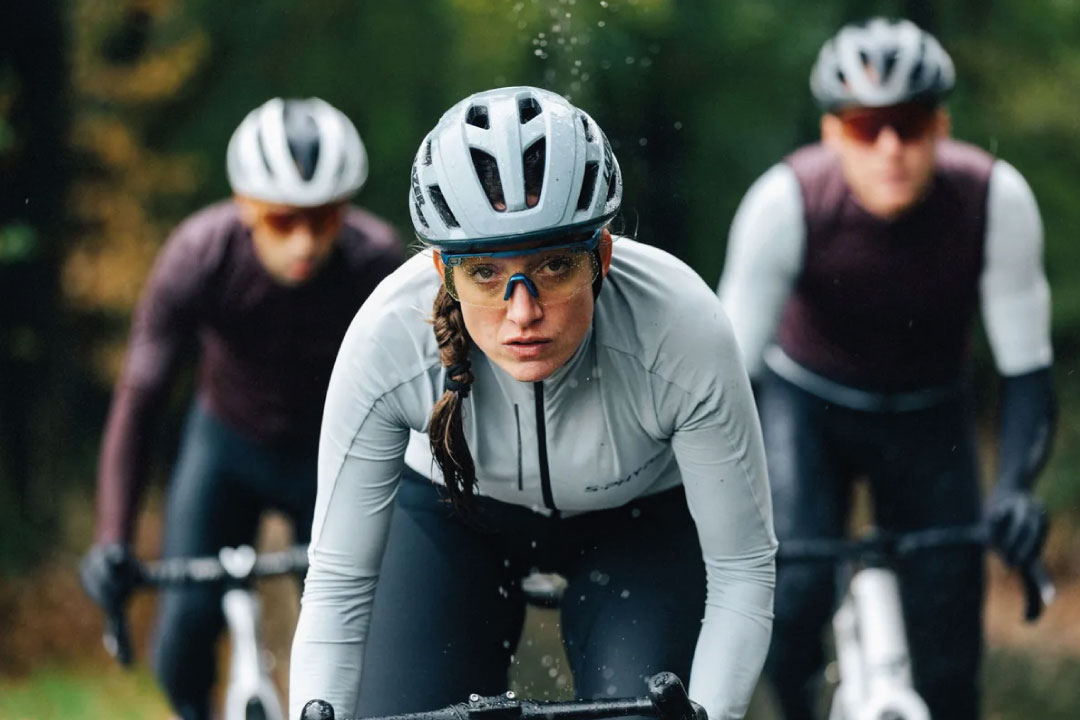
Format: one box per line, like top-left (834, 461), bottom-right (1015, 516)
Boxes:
top-left (289, 87), bottom-right (777, 720)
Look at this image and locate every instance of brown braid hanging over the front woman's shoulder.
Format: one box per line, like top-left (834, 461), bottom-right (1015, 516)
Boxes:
top-left (428, 287), bottom-right (476, 513)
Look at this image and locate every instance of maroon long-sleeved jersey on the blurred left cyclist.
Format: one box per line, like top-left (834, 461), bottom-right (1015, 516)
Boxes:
top-left (92, 202), bottom-right (403, 539)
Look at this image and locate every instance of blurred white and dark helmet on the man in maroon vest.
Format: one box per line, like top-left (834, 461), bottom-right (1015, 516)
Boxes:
top-left (810, 17), bottom-right (956, 112)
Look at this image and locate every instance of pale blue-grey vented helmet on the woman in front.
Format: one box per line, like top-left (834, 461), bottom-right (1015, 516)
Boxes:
top-left (409, 87), bottom-right (622, 250)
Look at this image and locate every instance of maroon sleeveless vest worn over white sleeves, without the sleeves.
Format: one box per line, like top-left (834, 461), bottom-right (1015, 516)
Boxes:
top-left (778, 140), bottom-right (994, 393)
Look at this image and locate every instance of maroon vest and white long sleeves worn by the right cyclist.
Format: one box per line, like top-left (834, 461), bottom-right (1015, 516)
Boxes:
top-left (719, 140), bottom-right (1052, 399)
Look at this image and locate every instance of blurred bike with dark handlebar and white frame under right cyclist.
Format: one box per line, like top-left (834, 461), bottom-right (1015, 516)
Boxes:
top-left (778, 525), bottom-right (1055, 720)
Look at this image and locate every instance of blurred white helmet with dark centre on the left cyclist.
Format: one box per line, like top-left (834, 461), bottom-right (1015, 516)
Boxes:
top-left (227, 97), bottom-right (367, 207)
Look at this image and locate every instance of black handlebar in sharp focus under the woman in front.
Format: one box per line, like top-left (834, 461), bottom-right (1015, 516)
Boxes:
top-left (300, 673), bottom-right (708, 720)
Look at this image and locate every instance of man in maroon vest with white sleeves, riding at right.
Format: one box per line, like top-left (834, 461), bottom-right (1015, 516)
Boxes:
top-left (719, 18), bottom-right (1054, 720)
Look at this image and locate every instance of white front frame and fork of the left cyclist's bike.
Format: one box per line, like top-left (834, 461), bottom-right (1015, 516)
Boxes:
top-left (221, 587), bottom-right (285, 720)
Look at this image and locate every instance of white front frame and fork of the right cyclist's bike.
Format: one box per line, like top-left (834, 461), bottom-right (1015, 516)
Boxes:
top-left (828, 568), bottom-right (930, 720)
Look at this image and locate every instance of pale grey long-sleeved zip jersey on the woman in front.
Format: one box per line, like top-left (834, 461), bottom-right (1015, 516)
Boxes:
top-left (289, 240), bottom-right (775, 720)
